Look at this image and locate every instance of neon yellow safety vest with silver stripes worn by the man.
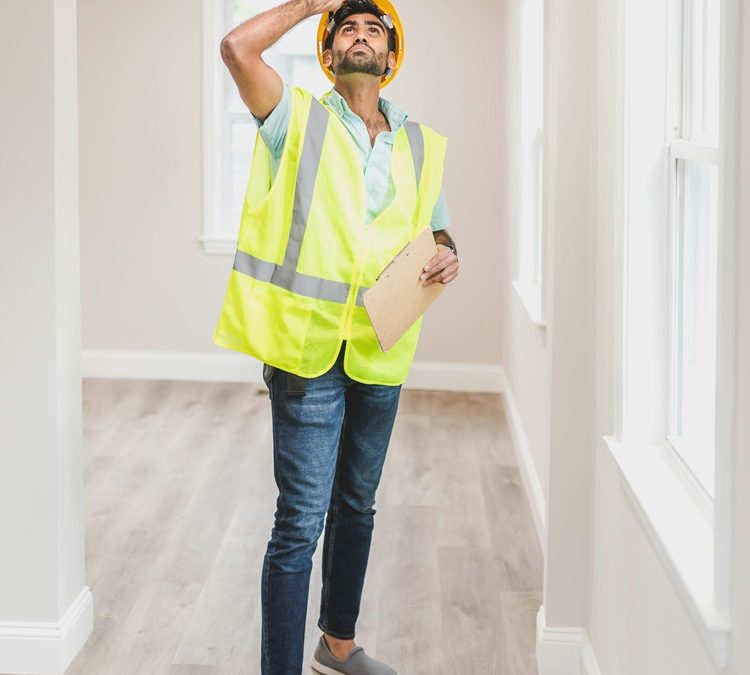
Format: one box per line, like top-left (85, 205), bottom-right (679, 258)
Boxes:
top-left (213, 87), bottom-right (448, 385)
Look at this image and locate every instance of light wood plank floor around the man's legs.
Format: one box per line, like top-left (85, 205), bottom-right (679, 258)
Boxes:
top-left (67, 380), bottom-right (542, 675)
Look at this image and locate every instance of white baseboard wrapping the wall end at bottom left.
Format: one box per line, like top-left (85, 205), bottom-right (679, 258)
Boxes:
top-left (0, 586), bottom-right (94, 675)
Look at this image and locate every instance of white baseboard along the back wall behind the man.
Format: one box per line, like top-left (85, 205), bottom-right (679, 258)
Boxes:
top-left (81, 349), bottom-right (503, 393)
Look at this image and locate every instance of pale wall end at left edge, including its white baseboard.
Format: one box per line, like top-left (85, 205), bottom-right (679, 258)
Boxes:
top-left (0, 0), bottom-right (93, 673)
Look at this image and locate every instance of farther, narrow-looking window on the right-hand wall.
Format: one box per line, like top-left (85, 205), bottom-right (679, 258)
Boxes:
top-left (513, 0), bottom-right (544, 326)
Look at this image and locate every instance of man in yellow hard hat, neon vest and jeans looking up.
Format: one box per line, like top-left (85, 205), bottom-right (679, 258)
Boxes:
top-left (214, 0), bottom-right (459, 675)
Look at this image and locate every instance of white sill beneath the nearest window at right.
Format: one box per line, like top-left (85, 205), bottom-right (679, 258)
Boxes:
top-left (604, 436), bottom-right (730, 669)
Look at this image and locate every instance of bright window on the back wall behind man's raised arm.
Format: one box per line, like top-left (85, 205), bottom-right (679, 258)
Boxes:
top-left (200, 0), bottom-right (331, 255)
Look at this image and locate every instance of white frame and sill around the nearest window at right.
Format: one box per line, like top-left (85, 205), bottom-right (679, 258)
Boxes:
top-left (604, 0), bottom-right (740, 669)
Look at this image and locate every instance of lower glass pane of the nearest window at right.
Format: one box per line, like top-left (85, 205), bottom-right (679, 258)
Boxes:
top-left (670, 160), bottom-right (718, 496)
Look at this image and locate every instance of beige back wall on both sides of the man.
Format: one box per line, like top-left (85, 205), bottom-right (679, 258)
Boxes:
top-left (78, 0), bottom-right (506, 365)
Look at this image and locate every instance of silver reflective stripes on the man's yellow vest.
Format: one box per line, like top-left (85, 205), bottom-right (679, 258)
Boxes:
top-left (234, 98), bottom-right (424, 307)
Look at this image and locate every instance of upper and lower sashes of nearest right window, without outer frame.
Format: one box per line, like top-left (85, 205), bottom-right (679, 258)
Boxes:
top-left (667, 0), bottom-right (720, 499)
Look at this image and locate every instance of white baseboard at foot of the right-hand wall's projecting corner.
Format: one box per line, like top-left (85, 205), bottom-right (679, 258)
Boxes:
top-left (536, 605), bottom-right (601, 675)
